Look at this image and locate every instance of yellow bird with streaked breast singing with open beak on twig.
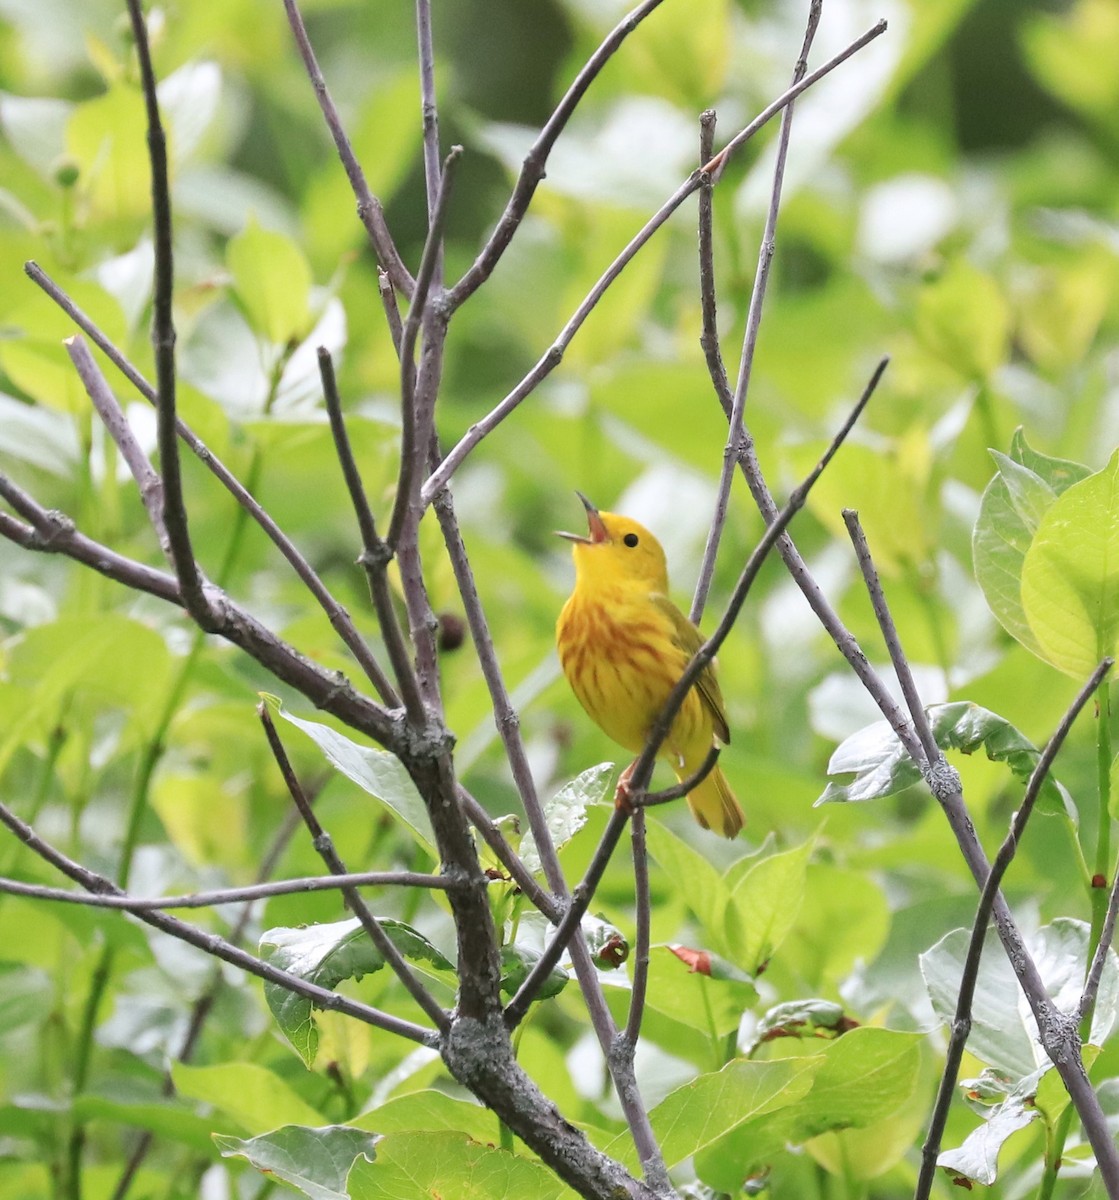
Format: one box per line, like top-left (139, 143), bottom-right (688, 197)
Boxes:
top-left (556, 492), bottom-right (744, 838)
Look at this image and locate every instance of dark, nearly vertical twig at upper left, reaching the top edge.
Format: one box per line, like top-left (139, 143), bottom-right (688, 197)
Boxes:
top-left (127, 0), bottom-right (213, 631)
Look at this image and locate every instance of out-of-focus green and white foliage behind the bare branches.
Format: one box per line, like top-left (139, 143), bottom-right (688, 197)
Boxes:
top-left (0, 0), bottom-right (1119, 1200)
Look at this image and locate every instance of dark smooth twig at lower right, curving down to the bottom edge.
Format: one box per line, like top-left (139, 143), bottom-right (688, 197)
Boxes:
top-left (912, 657), bottom-right (1113, 1200)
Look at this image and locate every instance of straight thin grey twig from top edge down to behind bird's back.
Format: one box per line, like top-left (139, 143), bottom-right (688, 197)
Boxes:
top-left (690, 0), bottom-right (822, 625)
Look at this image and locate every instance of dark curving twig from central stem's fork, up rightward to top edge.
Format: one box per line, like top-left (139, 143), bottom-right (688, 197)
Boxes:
top-left (447, 0), bottom-right (667, 308)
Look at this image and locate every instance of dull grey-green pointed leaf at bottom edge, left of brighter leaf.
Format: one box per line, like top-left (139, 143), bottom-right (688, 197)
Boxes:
top-left (214, 1126), bottom-right (377, 1200)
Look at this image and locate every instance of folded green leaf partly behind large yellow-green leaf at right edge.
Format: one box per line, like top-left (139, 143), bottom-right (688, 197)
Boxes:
top-left (971, 428), bottom-right (1090, 658)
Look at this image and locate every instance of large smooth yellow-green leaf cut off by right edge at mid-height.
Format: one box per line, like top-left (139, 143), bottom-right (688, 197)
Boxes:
top-left (1022, 452), bottom-right (1119, 679)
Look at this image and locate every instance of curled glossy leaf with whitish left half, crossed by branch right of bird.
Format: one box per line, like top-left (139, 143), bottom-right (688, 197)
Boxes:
top-left (816, 700), bottom-right (1075, 817)
